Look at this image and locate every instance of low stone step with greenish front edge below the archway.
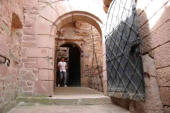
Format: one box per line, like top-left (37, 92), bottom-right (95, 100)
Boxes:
top-left (17, 96), bottom-right (111, 105)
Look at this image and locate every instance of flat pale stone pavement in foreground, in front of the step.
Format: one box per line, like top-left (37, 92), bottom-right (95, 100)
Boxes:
top-left (8, 104), bottom-right (130, 113)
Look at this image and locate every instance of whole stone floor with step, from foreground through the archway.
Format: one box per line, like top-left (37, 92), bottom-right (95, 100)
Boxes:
top-left (8, 87), bottom-right (130, 113)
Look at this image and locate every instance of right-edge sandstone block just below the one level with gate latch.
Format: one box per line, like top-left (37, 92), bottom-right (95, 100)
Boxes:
top-left (157, 67), bottom-right (170, 86)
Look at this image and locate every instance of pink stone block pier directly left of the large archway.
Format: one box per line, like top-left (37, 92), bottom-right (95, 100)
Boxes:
top-left (19, 0), bottom-right (54, 96)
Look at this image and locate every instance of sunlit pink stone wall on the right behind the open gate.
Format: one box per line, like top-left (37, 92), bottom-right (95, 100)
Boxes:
top-left (137, 0), bottom-right (170, 113)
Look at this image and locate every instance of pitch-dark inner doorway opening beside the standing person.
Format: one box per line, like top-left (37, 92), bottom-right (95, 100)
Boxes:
top-left (61, 44), bottom-right (81, 86)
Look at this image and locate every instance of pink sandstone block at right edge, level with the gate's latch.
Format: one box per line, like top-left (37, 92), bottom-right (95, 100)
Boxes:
top-left (154, 42), bottom-right (170, 68)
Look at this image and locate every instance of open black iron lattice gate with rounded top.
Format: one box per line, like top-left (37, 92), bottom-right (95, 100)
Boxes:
top-left (105, 0), bottom-right (145, 100)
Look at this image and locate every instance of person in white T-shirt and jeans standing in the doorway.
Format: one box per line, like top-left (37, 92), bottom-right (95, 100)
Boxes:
top-left (58, 57), bottom-right (67, 87)
